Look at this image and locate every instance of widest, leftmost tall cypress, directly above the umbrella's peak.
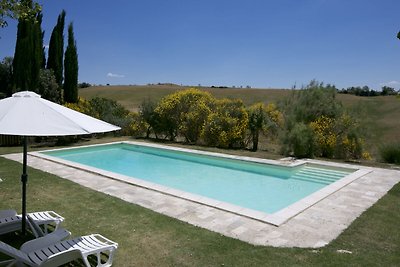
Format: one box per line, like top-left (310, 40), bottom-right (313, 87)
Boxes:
top-left (13, 0), bottom-right (44, 91)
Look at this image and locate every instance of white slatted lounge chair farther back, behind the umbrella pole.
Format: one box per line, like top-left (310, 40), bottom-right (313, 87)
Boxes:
top-left (0, 210), bottom-right (64, 237)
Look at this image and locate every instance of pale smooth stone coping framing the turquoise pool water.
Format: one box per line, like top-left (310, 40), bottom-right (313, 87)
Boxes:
top-left (29, 141), bottom-right (372, 226)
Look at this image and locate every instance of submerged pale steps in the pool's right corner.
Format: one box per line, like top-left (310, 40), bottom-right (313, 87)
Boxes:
top-left (291, 166), bottom-right (348, 185)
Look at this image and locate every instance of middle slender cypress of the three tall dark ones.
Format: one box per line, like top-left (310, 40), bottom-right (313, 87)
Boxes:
top-left (47, 10), bottom-right (65, 87)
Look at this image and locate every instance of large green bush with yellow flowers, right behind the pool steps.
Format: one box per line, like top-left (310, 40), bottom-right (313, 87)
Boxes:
top-left (282, 81), bottom-right (368, 159)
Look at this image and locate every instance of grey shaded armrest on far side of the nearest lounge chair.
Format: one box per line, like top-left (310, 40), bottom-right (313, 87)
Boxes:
top-left (20, 228), bottom-right (71, 253)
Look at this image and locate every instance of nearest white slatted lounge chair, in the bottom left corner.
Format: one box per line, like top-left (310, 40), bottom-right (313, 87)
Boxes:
top-left (0, 228), bottom-right (118, 267)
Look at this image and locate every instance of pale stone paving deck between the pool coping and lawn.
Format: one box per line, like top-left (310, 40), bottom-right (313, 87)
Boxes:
top-left (3, 153), bottom-right (400, 248)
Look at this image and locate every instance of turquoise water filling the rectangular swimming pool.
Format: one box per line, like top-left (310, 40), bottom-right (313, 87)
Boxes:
top-left (43, 143), bottom-right (354, 213)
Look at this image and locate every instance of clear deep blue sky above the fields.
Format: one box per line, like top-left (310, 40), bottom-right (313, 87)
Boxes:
top-left (0, 0), bottom-right (400, 89)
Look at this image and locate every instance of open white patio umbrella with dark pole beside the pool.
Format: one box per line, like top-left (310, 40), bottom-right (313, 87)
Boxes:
top-left (0, 91), bottom-right (121, 234)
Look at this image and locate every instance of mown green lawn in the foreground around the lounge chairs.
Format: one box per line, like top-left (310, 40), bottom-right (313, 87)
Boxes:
top-left (0, 140), bottom-right (400, 266)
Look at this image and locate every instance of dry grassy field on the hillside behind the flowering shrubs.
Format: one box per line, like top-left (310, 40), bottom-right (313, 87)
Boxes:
top-left (79, 85), bottom-right (400, 158)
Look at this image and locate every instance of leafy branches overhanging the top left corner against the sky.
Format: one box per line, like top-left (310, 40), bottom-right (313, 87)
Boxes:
top-left (0, 0), bottom-right (42, 28)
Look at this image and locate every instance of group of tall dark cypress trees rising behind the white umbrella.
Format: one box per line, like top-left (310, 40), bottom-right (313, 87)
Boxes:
top-left (0, 0), bottom-right (78, 103)
